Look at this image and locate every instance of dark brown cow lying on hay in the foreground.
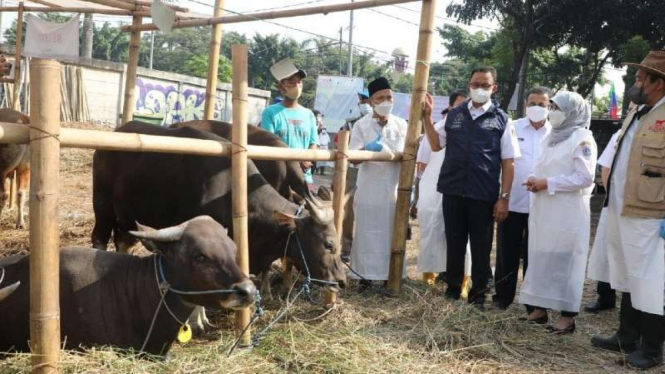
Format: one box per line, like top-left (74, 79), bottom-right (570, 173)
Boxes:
top-left (0, 216), bottom-right (256, 355)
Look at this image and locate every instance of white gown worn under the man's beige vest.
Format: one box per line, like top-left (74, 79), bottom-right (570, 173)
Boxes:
top-left (605, 98), bottom-right (665, 315)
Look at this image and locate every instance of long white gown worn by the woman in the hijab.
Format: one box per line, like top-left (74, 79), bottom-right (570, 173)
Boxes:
top-left (519, 129), bottom-right (597, 312)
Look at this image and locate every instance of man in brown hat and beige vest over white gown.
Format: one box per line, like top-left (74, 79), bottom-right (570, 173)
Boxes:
top-left (591, 51), bottom-right (665, 369)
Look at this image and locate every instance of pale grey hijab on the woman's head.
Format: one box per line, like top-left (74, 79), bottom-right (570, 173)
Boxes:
top-left (548, 91), bottom-right (591, 147)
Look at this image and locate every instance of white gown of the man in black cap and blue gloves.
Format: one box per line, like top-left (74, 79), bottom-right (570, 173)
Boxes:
top-left (349, 115), bottom-right (407, 280)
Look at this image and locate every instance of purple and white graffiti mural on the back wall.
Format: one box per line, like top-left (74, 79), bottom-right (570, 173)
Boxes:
top-left (134, 78), bottom-right (225, 126)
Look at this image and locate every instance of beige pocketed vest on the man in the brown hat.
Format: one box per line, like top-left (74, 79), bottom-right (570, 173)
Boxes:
top-left (615, 105), bottom-right (665, 218)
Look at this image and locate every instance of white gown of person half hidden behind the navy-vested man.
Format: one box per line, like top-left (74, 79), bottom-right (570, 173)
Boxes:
top-left (418, 121), bottom-right (448, 273)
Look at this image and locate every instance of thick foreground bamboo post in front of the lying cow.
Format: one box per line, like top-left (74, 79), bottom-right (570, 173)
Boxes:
top-left (30, 59), bottom-right (61, 374)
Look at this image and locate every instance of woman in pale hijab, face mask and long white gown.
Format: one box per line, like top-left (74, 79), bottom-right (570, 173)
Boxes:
top-left (519, 92), bottom-right (597, 334)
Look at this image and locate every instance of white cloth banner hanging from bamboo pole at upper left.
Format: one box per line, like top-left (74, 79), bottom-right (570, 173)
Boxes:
top-left (23, 14), bottom-right (79, 58)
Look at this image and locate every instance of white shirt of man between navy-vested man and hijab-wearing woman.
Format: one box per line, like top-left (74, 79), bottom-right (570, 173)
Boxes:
top-left (508, 117), bottom-right (552, 213)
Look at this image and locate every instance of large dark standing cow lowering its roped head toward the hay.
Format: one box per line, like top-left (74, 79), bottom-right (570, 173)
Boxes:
top-left (92, 123), bottom-right (346, 291)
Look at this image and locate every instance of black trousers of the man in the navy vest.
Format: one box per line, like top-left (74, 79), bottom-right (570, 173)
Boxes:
top-left (443, 195), bottom-right (494, 302)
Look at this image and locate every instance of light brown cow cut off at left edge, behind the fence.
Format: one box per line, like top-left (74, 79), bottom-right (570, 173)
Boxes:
top-left (0, 108), bottom-right (30, 229)
